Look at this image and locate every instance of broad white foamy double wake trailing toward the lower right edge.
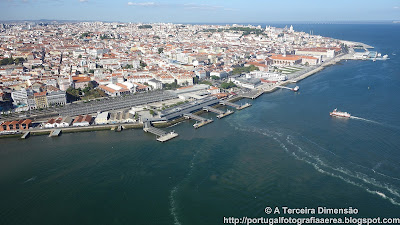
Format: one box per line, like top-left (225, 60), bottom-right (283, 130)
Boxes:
top-left (230, 124), bottom-right (400, 205)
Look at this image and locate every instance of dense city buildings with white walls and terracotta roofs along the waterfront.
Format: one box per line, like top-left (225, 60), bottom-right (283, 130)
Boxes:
top-left (0, 22), bottom-right (356, 130)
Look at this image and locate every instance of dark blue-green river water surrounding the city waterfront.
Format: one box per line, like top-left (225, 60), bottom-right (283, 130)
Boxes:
top-left (0, 24), bottom-right (400, 224)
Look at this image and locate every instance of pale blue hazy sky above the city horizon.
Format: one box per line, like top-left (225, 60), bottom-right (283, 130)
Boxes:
top-left (0, 0), bottom-right (400, 23)
